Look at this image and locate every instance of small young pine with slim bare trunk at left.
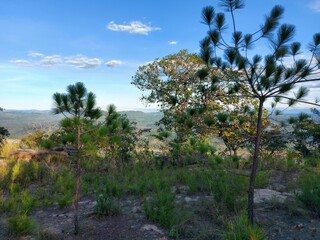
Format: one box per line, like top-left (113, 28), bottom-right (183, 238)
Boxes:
top-left (52, 82), bottom-right (102, 234)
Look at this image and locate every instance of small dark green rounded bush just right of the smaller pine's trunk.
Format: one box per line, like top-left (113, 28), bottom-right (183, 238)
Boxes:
top-left (95, 193), bottom-right (120, 216)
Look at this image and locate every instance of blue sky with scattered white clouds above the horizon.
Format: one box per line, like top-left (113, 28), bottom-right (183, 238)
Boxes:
top-left (0, 0), bottom-right (320, 110)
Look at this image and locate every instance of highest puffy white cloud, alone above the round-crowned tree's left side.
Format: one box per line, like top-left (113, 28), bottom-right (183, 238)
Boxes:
top-left (107, 21), bottom-right (161, 35)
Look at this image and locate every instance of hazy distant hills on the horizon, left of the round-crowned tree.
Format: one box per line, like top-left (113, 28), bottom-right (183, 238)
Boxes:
top-left (0, 110), bottom-right (162, 139)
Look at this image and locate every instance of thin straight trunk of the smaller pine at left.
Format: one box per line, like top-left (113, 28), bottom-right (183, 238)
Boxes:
top-left (73, 126), bottom-right (81, 235)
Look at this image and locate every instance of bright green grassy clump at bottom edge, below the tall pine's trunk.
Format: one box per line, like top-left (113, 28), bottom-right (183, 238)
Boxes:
top-left (224, 214), bottom-right (265, 240)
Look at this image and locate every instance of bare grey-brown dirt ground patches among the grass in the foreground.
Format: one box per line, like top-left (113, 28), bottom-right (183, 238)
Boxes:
top-left (0, 172), bottom-right (320, 240)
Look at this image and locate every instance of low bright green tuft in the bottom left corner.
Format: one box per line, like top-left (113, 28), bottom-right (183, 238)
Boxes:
top-left (8, 214), bottom-right (37, 236)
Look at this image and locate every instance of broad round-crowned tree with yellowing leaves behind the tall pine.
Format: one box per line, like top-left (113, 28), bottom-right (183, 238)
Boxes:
top-left (132, 50), bottom-right (254, 151)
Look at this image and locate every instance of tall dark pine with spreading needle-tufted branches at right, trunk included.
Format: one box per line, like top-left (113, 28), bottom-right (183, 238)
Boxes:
top-left (200, 0), bottom-right (320, 224)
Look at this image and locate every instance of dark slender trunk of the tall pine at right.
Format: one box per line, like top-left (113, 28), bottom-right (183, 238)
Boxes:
top-left (247, 98), bottom-right (265, 225)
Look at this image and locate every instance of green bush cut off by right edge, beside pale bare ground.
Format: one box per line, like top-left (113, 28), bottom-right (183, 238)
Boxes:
top-left (297, 173), bottom-right (320, 216)
